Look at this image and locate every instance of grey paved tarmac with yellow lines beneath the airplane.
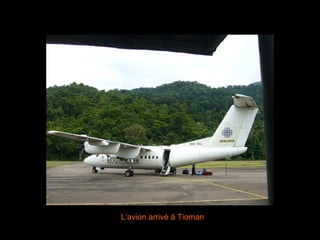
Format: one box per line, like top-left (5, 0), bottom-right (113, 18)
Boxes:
top-left (46, 162), bottom-right (269, 206)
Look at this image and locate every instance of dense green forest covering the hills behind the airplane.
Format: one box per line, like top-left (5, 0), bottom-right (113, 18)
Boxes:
top-left (46, 81), bottom-right (266, 160)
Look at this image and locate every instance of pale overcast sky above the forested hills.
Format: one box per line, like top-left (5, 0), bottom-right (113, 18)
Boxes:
top-left (46, 35), bottom-right (261, 91)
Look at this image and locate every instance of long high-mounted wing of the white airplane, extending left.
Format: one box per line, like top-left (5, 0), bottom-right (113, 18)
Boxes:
top-left (48, 130), bottom-right (150, 151)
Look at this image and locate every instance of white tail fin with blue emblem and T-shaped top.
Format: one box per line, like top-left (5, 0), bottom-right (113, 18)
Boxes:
top-left (209, 94), bottom-right (258, 147)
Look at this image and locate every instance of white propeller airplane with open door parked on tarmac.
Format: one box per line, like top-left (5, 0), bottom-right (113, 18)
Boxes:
top-left (48, 94), bottom-right (258, 177)
